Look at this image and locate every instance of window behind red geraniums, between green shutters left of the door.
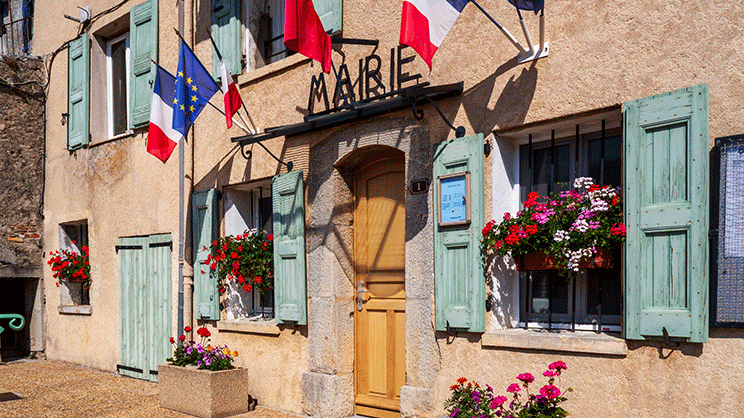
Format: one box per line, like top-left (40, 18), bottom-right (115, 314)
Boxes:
top-left (224, 182), bottom-right (274, 320)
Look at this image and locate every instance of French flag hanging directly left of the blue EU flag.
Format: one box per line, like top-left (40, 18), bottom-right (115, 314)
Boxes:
top-left (147, 65), bottom-right (182, 162)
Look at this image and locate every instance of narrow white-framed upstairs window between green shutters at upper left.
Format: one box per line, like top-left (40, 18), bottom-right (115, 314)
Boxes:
top-left (106, 33), bottom-right (129, 138)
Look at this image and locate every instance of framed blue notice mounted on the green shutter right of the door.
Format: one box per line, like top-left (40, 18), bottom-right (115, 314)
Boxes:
top-left (437, 171), bottom-right (470, 226)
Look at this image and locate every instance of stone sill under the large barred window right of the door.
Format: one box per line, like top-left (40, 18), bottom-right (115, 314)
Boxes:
top-left (481, 329), bottom-right (628, 357)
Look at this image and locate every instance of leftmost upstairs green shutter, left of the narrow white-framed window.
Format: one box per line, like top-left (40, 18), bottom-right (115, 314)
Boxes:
top-left (67, 33), bottom-right (90, 150)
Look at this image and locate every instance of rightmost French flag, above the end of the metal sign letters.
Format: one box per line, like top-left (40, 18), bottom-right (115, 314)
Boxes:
top-left (400, 0), bottom-right (468, 70)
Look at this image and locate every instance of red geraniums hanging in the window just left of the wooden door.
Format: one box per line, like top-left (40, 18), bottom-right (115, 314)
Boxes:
top-left (204, 229), bottom-right (274, 295)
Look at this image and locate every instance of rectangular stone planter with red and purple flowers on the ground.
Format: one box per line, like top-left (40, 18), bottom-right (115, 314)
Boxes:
top-left (158, 327), bottom-right (250, 418)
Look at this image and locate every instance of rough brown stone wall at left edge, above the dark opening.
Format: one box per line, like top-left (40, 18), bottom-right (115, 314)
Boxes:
top-left (0, 57), bottom-right (44, 269)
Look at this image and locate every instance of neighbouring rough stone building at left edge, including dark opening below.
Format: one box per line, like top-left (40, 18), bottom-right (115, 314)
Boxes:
top-left (0, 56), bottom-right (44, 357)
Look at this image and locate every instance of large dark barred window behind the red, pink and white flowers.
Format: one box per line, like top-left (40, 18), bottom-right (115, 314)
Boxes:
top-left (519, 120), bottom-right (622, 331)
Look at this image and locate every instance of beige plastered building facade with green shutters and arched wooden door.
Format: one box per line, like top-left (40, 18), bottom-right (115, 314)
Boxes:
top-left (34, 0), bottom-right (744, 417)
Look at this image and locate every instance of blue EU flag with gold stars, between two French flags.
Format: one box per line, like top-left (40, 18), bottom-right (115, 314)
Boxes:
top-left (173, 39), bottom-right (220, 138)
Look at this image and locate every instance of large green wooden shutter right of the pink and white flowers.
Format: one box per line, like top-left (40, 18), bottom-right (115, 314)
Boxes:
top-left (624, 84), bottom-right (709, 342)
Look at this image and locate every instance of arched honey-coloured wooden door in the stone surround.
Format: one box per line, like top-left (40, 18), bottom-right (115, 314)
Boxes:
top-left (354, 154), bottom-right (406, 417)
